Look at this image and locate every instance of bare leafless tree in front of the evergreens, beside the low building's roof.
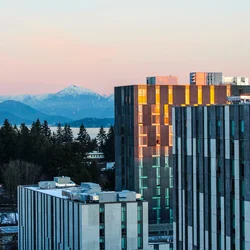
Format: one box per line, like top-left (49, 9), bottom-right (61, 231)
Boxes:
top-left (2, 160), bottom-right (42, 202)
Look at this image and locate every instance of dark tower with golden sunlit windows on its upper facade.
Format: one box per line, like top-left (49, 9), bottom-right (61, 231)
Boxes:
top-left (115, 81), bottom-right (231, 235)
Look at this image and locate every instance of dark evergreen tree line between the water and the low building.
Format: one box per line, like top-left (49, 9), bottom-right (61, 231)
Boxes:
top-left (0, 120), bottom-right (115, 205)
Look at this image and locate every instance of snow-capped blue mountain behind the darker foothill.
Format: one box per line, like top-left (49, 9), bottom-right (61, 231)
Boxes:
top-left (0, 85), bottom-right (114, 120)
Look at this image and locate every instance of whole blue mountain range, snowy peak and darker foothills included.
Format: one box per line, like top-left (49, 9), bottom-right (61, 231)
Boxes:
top-left (0, 85), bottom-right (114, 124)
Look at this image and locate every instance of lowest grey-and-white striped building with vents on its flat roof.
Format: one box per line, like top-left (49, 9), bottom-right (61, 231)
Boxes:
top-left (18, 177), bottom-right (149, 250)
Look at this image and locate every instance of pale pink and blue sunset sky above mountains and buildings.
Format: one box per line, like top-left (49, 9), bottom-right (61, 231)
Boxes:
top-left (0, 0), bottom-right (250, 95)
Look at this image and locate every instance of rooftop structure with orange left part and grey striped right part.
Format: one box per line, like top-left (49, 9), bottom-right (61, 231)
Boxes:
top-left (190, 72), bottom-right (223, 85)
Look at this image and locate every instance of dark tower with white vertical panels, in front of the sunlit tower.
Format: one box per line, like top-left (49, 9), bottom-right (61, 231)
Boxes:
top-left (172, 104), bottom-right (250, 250)
